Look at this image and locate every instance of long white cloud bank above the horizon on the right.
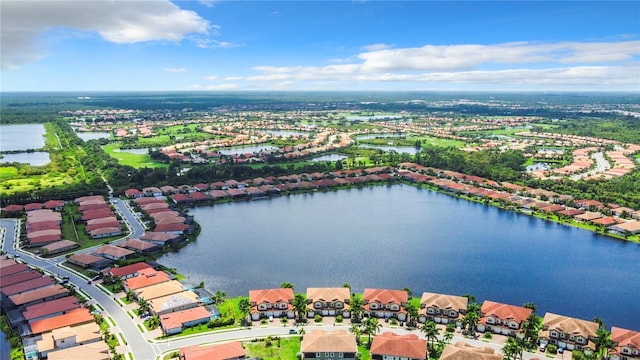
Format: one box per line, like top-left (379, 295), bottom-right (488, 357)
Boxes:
top-left (247, 41), bottom-right (640, 88)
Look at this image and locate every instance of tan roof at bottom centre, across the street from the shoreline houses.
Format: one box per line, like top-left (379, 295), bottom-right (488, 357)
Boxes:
top-left (300, 329), bottom-right (358, 353)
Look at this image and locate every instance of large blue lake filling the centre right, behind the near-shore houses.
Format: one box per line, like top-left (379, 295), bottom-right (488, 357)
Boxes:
top-left (159, 185), bottom-right (640, 329)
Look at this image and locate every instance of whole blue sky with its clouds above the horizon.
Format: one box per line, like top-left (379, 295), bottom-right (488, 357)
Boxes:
top-left (0, 0), bottom-right (640, 91)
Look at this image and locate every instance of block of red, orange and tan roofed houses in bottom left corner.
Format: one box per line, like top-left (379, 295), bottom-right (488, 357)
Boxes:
top-left (0, 256), bottom-right (110, 360)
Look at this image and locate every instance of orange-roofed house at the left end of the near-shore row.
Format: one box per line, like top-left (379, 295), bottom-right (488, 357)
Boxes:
top-left (249, 288), bottom-right (295, 321)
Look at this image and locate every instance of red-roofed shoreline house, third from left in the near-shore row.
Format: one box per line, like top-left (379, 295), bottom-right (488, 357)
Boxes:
top-left (362, 289), bottom-right (409, 321)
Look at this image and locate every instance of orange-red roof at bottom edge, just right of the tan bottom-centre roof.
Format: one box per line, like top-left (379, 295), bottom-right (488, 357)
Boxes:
top-left (371, 332), bottom-right (427, 359)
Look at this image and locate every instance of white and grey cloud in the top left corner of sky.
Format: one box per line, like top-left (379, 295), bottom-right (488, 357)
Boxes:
top-left (1, 0), bottom-right (215, 70)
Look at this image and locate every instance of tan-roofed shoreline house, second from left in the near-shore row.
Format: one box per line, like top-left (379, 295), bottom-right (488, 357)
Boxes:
top-left (307, 287), bottom-right (351, 318)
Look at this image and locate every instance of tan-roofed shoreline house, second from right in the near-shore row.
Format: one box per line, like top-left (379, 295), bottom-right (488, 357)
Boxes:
top-left (539, 313), bottom-right (598, 353)
